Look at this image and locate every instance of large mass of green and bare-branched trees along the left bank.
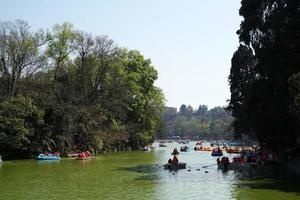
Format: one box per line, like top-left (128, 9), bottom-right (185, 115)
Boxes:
top-left (0, 20), bottom-right (164, 158)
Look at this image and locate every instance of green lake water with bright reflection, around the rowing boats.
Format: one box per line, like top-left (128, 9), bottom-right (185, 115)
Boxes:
top-left (0, 142), bottom-right (300, 200)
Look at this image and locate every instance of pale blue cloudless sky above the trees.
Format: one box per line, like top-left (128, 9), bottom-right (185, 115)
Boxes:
top-left (0, 0), bottom-right (241, 108)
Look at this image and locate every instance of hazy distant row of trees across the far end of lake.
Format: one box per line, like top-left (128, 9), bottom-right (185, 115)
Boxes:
top-left (158, 104), bottom-right (232, 138)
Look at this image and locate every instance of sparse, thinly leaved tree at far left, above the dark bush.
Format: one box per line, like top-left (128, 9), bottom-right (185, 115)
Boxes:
top-left (0, 20), bottom-right (47, 98)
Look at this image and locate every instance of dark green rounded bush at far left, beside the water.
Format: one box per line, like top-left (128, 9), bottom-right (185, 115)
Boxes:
top-left (0, 97), bottom-right (44, 151)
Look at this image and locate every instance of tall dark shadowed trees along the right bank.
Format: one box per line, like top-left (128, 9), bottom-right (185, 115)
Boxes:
top-left (228, 0), bottom-right (300, 151)
